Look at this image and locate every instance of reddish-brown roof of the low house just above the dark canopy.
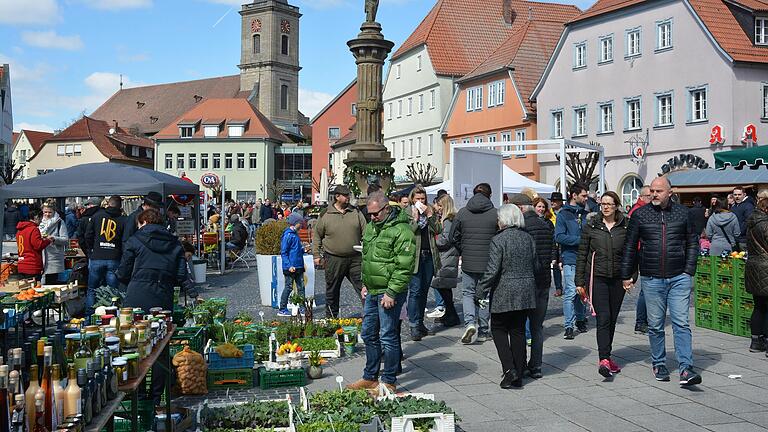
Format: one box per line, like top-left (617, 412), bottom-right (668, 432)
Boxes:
top-left (36, 116), bottom-right (154, 163)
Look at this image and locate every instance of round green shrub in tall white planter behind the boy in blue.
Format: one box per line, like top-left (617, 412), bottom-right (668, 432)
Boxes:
top-left (254, 221), bottom-right (315, 308)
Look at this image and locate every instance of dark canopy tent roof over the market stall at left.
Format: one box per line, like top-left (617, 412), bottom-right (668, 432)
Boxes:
top-left (0, 162), bottom-right (200, 254)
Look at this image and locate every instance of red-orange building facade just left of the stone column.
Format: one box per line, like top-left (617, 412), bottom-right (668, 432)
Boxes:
top-left (311, 79), bottom-right (357, 201)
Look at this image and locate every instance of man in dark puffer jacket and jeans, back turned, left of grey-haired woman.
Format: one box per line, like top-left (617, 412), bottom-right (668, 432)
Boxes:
top-left (451, 183), bottom-right (499, 344)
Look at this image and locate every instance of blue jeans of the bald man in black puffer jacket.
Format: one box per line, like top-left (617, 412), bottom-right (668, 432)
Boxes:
top-left (640, 273), bottom-right (693, 373)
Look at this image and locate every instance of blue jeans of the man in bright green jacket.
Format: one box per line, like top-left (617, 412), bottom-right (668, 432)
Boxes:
top-left (360, 293), bottom-right (406, 384)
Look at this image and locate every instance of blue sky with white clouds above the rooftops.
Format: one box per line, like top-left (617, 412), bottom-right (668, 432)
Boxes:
top-left (0, 0), bottom-right (592, 131)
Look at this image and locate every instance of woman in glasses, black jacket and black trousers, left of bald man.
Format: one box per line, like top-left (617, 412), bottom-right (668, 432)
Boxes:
top-left (575, 191), bottom-right (628, 378)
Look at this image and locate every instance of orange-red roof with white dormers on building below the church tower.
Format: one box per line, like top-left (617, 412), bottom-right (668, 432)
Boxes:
top-left (155, 99), bottom-right (291, 142)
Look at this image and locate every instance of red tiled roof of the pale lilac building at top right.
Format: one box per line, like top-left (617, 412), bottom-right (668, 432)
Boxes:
top-left (571, 0), bottom-right (768, 63)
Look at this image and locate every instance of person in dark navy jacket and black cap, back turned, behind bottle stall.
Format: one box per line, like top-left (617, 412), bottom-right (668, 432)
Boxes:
top-left (117, 209), bottom-right (187, 406)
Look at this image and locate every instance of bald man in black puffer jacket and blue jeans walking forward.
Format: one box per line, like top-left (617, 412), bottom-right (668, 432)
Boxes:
top-left (621, 177), bottom-right (701, 385)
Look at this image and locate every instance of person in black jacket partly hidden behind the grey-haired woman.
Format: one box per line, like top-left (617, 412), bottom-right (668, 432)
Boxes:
top-left (510, 194), bottom-right (557, 379)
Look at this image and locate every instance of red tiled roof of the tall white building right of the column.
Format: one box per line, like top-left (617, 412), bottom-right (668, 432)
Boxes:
top-left (392, 0), bottom-right (580, 76)
